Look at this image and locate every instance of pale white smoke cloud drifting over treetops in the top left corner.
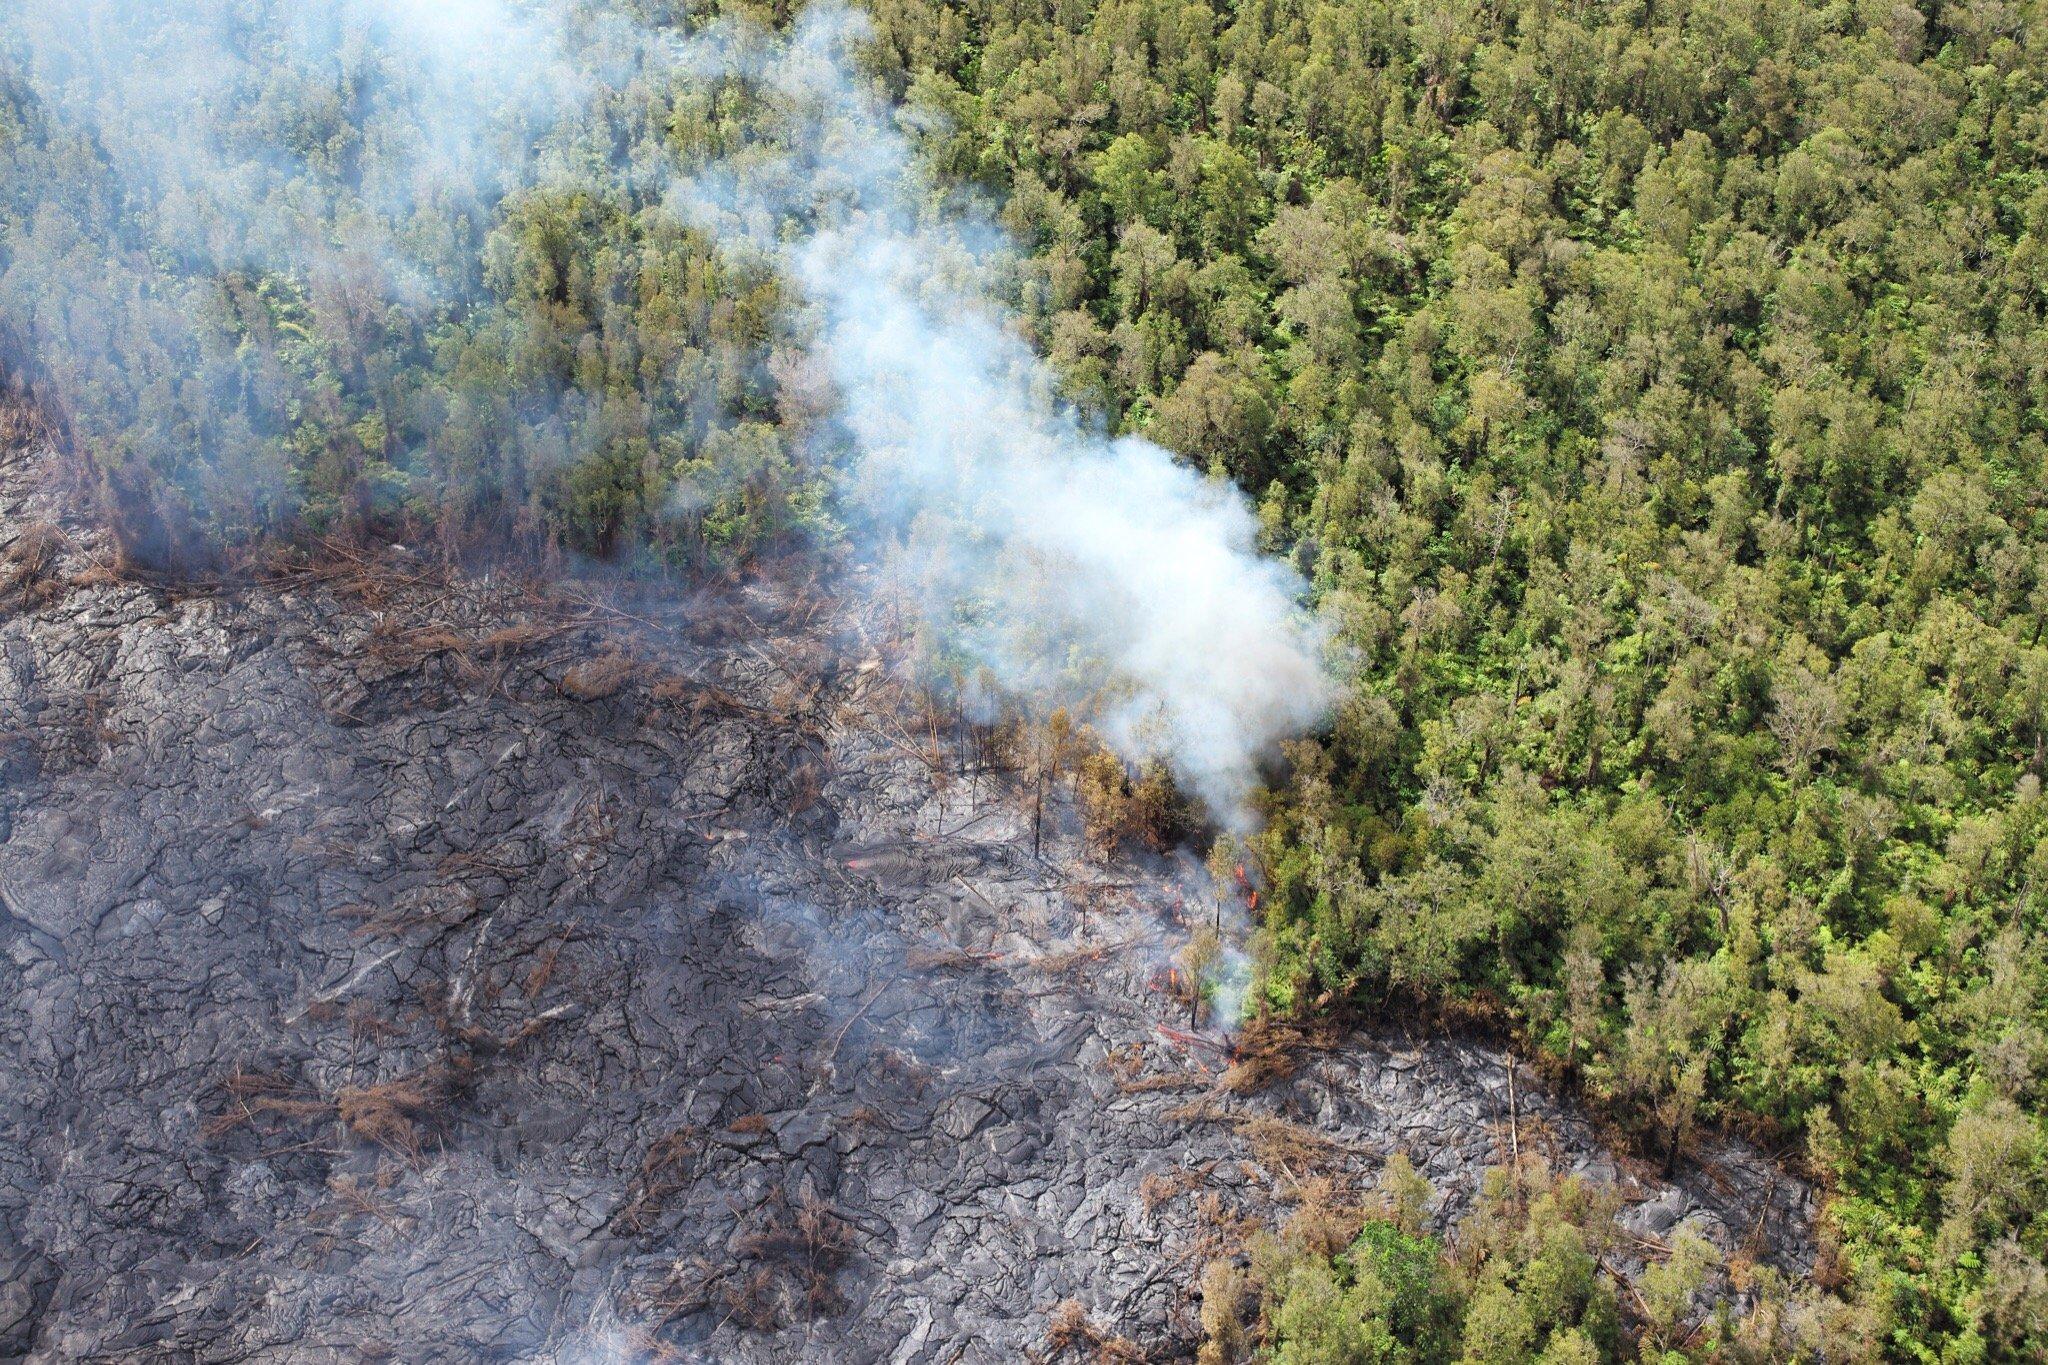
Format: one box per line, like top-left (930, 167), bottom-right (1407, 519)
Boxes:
top-left (0, 0), bottom-right (598, 286)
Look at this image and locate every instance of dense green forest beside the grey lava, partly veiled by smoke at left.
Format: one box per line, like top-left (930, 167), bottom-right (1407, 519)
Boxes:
top-left (12, 0), bottom-right (2048, 1359)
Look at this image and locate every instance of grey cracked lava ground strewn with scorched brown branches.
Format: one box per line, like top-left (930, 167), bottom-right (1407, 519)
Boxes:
top-left (0, 431), bottom-right (1812, 1361)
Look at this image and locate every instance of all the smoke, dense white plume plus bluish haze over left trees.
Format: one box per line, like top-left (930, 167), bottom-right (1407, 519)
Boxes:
top-left (0, 0), bottom-right (1329, 823)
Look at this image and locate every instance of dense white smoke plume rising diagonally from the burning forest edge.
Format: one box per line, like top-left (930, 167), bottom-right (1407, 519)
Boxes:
top-left (674, 2), bottom-right (1331, 825)
